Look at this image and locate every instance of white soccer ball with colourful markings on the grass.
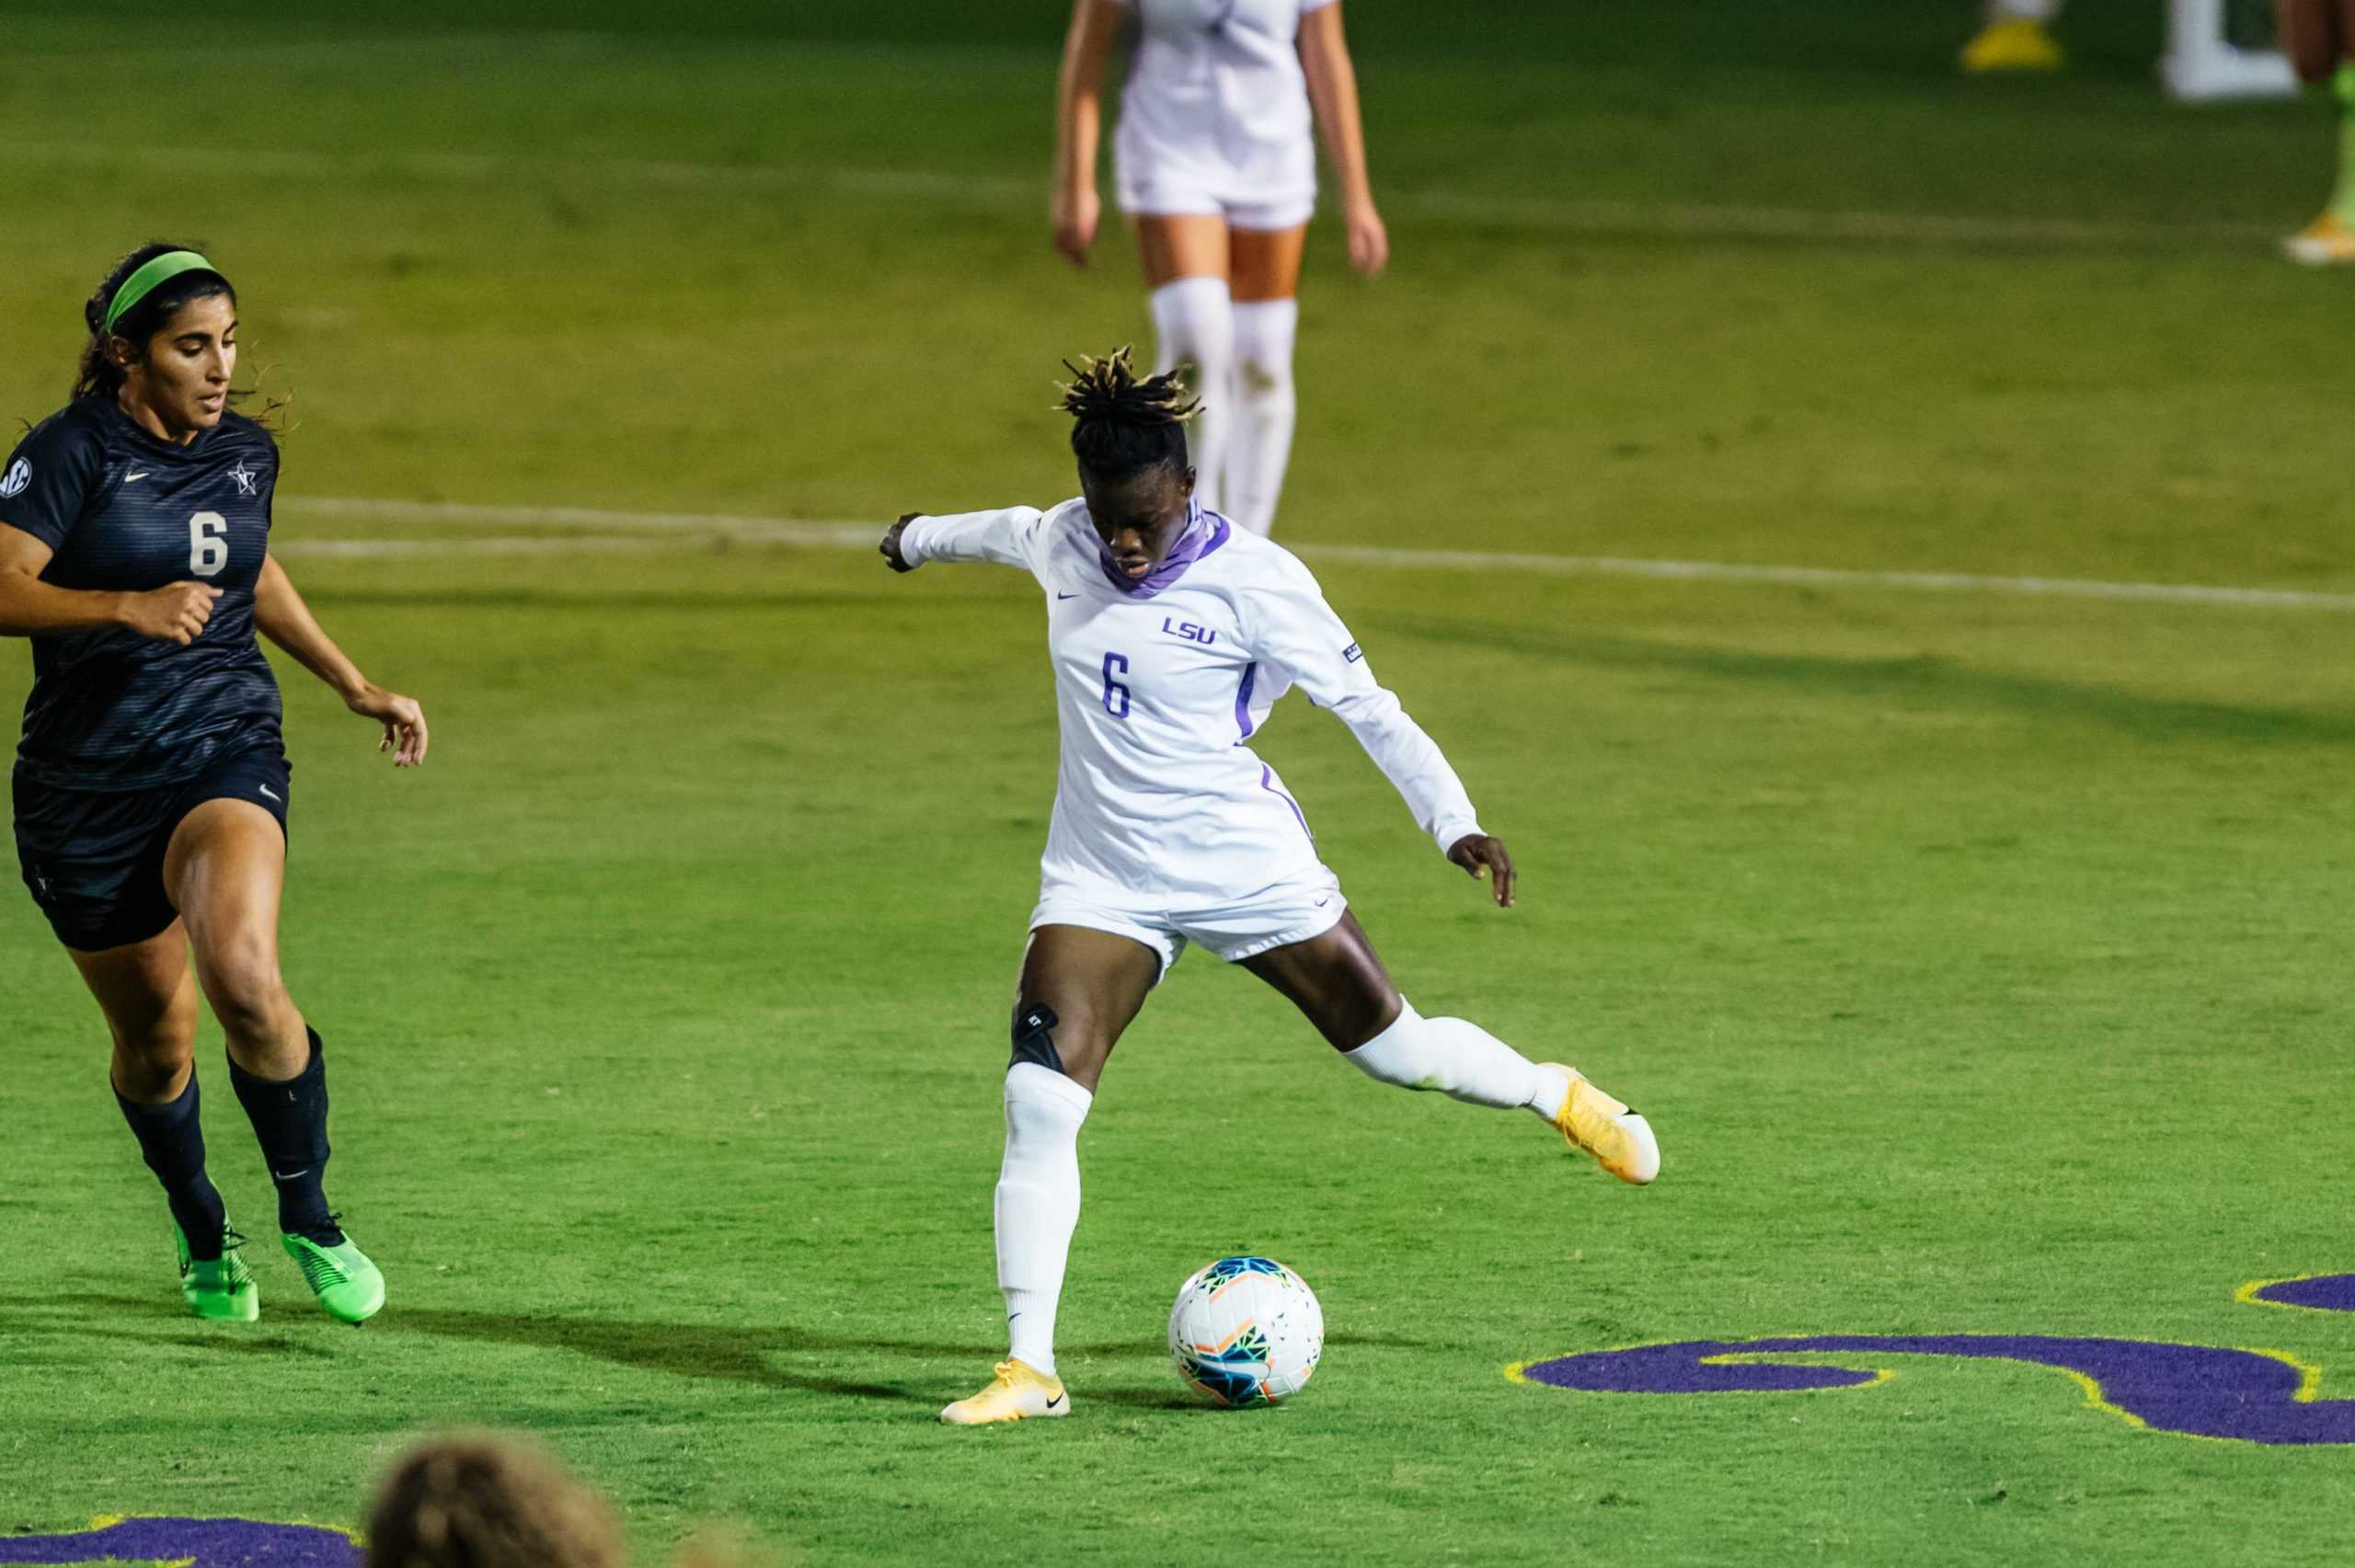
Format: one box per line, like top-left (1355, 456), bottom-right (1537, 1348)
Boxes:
top-left (1170, 1257), bottom-right (1324, 1405)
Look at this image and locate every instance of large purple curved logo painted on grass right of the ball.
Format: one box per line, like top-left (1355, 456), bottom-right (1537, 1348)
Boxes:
top-left (1522, 1335), bottom-right (2355, 1443)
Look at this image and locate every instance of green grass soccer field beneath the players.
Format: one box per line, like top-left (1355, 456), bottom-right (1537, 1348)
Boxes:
top-left (0, 0), bottom-right (2355, 1565)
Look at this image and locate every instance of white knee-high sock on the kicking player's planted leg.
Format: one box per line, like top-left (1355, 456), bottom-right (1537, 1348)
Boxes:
top-left (996, 1062), bottom-right (1095, 1378)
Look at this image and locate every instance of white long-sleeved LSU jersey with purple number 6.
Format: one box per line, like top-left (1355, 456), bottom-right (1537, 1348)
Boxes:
top-left (900, 499), bottom-right (1479, 904)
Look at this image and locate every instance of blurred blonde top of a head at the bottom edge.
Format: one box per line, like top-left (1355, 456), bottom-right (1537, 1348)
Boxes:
top-left (367, 1436), bottom-right (626, 1568)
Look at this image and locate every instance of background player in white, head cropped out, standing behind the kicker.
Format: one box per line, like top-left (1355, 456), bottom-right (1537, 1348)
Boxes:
top-left (1052, 0), bottom-right (1389, 534)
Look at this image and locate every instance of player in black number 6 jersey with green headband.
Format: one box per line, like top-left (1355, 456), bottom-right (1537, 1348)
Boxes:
top-left (0, 243), bottom-right (426, 1323)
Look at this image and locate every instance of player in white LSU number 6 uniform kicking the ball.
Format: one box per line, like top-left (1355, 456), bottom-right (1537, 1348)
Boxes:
top-left (880, 349), bottom-right (1660, 1425)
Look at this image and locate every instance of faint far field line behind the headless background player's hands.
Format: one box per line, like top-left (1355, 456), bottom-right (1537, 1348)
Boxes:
top-left (7, 142), bottom-right (2275, 247)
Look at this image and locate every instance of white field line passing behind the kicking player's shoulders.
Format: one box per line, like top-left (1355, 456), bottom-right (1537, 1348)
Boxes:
top-left (273, 497), bottom-right (2355, 614)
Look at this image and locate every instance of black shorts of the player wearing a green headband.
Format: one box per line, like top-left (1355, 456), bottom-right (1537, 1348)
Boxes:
top-left (17, 737), bottom-right (294, 954)
